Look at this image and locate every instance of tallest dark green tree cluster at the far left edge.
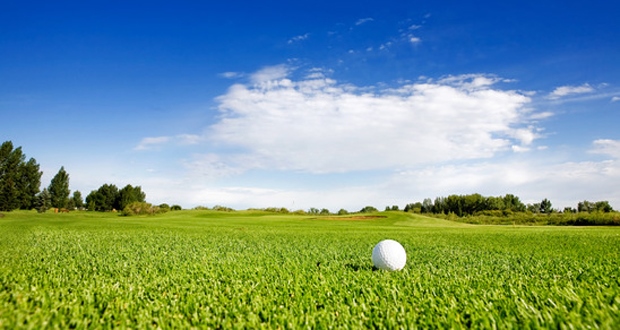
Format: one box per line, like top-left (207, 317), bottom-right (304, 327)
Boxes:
top-left (0, 141), bottom-right (42, 211)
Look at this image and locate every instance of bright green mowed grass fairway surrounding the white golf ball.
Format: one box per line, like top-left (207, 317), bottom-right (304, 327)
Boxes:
top-left (0, 211), bottom-right (620, 329)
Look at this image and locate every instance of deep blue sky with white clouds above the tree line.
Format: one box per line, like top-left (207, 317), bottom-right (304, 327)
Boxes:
top-left (0, 0), bottom-right (620, 212)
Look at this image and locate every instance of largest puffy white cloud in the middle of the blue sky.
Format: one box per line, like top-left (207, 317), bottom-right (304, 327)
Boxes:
top-left (207, 66), bottom-right (537, 173)
